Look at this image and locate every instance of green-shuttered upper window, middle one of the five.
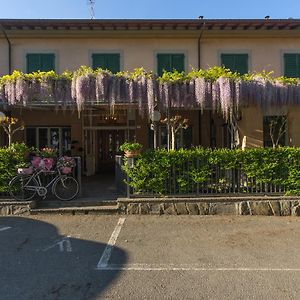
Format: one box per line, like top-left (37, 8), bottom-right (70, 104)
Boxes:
top-left (157, 54), bottom-right (185, 76)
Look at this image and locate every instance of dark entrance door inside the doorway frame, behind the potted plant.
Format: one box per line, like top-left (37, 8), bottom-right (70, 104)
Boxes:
top-left (96, 129), bottom-right (126, 173)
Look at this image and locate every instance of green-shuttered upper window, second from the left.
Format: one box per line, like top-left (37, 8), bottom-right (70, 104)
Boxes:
top-left (92, 53), bottom-right (120, 73)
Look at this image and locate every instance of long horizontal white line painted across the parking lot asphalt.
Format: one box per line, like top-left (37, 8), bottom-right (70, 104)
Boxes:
top-left (97, 264), bottom-right (300, 272)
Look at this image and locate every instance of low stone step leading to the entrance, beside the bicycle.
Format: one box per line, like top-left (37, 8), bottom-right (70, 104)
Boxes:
top-left (38, 199), bottom-right (117, 208)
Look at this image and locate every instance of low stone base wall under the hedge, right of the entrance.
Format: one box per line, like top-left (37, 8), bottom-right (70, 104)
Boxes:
top-left (118, 197), bottom-right (300, 216)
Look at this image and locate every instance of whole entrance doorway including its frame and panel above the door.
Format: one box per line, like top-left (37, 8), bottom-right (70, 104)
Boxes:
top-left (83, 108), bottom-right (136, 176)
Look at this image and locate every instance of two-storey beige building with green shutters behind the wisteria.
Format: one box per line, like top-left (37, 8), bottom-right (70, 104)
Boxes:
top-left (0, 19), bottom-right (300, 175)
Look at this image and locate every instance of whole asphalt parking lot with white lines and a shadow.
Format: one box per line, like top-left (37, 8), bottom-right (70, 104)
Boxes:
top-left (0, 215), bottom-right (300, 299)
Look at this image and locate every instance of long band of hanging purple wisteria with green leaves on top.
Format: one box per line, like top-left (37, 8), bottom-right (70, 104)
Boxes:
top-left (0, 67), bottom-right (300, 118)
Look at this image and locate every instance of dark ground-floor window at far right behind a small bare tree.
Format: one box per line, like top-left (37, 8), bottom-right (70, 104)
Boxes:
top-left (263, 116), bottom-right (287, 147)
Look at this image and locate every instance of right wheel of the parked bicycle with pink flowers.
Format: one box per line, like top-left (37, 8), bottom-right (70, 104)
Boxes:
top-left (53, 176), bottom-right (79, 201)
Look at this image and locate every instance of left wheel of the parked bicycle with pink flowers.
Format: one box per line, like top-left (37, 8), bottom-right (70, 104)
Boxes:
top-left (9, 175), bottom-right (39, 201)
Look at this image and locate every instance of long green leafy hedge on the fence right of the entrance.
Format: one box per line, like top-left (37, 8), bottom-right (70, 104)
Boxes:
top-left (123, 147), bottom-right (300, 194)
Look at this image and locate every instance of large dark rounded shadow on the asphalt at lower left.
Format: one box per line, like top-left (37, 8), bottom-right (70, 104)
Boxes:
top-left (0, 217), bottom-right (127, 300)
